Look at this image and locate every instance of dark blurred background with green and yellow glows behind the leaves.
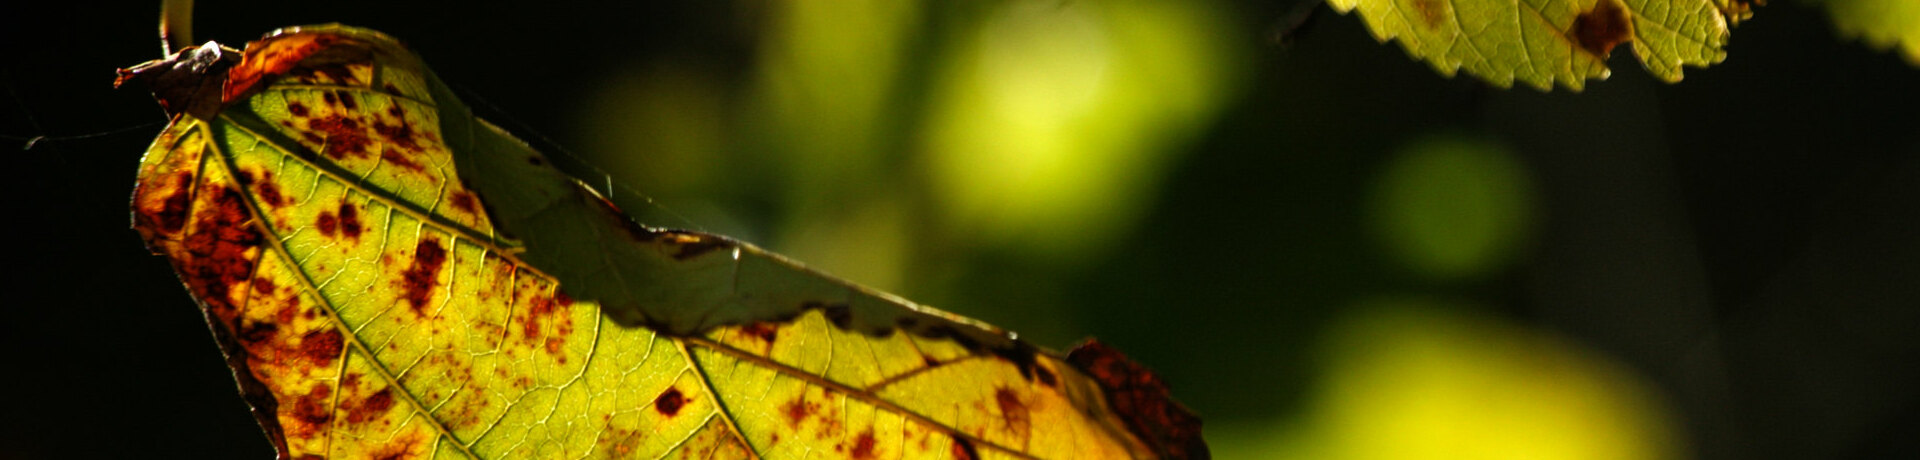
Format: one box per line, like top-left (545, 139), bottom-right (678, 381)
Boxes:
top-left (0, 0), bottom-right (1920, 458)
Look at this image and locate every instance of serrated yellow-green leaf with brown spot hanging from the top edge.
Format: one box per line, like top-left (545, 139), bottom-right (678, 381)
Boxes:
top-left (1327, 0), bottom-right (1745, 90)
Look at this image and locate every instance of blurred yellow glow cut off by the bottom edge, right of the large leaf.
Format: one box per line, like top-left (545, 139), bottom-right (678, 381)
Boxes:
top-left (1267, 301), bottom-right (1680, 460)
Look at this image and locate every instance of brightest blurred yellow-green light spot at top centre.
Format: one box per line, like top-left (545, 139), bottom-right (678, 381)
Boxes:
top-left (925, 2), bottom-right (1236, 257)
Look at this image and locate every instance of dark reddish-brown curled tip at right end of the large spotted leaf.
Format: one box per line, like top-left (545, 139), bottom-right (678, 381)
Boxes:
top-left (1068, 339), bottom-right (1213, 458)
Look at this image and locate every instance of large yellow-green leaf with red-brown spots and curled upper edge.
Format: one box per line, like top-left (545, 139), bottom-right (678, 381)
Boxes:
top-left (123, 25), bottom-right (1206, 458)
